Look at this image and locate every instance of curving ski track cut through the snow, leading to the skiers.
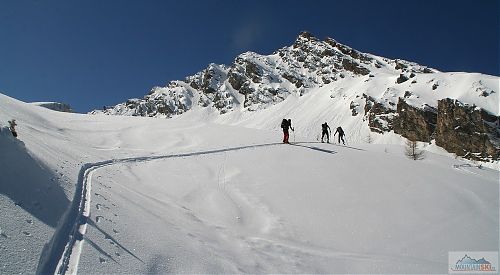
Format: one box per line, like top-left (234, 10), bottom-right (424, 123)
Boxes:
top-left (37, 142), bottom-right (352, 274)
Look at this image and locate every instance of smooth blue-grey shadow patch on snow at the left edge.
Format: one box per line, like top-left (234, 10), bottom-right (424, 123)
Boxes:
top-left (0, 128), bottom-right (70, 228)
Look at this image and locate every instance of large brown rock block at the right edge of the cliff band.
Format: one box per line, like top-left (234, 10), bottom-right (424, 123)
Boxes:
top-left (436, 98), bottom-right (500, 160)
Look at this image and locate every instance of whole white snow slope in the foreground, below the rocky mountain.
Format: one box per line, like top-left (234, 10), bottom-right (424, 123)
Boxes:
top-left (0, 92), bottom-right (499, 273)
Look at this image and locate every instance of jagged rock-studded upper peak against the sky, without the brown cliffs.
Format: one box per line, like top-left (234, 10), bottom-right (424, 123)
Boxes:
top-left (93, 31), bottom-right (437, 117)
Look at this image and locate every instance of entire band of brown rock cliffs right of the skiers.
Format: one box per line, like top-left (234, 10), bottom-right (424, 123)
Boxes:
top-left (364, 95), bottom-right (500, 161)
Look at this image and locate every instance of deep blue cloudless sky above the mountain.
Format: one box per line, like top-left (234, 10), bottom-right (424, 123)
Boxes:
top-left (0, 0), bottom-right (500, 112)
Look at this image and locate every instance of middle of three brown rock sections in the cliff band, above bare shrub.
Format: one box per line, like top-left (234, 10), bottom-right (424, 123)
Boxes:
top-left (394, 98), bottom-right (437, 142)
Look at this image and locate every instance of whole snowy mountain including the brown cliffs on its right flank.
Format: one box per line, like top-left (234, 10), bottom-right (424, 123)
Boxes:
top-left (92, 32), bottom-right (500, 160)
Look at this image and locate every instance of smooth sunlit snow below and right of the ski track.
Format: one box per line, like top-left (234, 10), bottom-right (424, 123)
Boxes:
top-left (80, 143), bottom-right (498, 273)
